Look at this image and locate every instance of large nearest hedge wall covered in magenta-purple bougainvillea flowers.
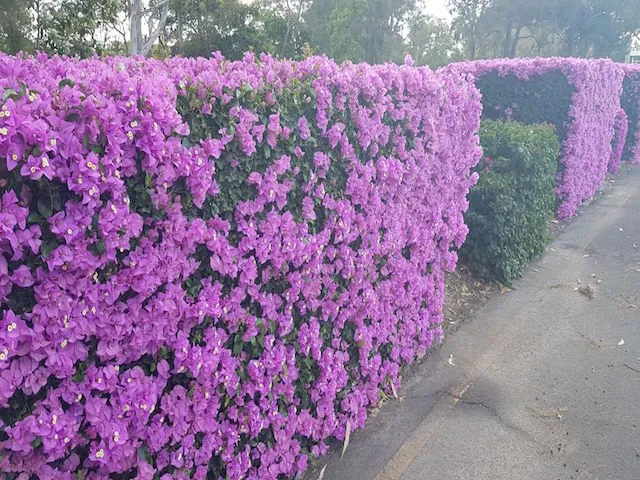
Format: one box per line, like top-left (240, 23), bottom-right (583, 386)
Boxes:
top-left (0, 54), bottom-right (480, 479)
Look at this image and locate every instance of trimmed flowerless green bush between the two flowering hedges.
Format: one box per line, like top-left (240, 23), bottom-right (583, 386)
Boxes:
top-left (460, 120), bottom-right (560, 284)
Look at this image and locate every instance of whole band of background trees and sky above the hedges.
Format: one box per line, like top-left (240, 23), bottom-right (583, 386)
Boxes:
top-left (0, 0), bottom-right (640, 67)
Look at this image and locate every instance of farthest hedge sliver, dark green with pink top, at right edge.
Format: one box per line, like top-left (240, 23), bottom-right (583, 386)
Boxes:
top-left (620, 64), bottom-right (640, 163)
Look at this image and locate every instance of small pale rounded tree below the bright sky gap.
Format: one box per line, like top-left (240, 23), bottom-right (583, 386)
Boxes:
top-left (407, 15), bottom-right (462, 68)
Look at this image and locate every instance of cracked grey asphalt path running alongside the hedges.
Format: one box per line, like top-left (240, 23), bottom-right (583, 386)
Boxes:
top-left (307, 167), bottom-right (640, 480)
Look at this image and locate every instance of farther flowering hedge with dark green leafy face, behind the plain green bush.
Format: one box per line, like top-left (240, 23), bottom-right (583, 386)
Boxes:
top-left (445, 58), bottom-right (624, 219)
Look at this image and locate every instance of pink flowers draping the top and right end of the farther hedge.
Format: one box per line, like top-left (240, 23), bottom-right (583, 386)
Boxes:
top-left (445, 58), bottom-right (624, 219)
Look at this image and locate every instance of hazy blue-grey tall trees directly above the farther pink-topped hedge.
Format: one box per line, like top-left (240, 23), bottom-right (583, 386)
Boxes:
top-left (448, 0), bottom-right (640, 60)
